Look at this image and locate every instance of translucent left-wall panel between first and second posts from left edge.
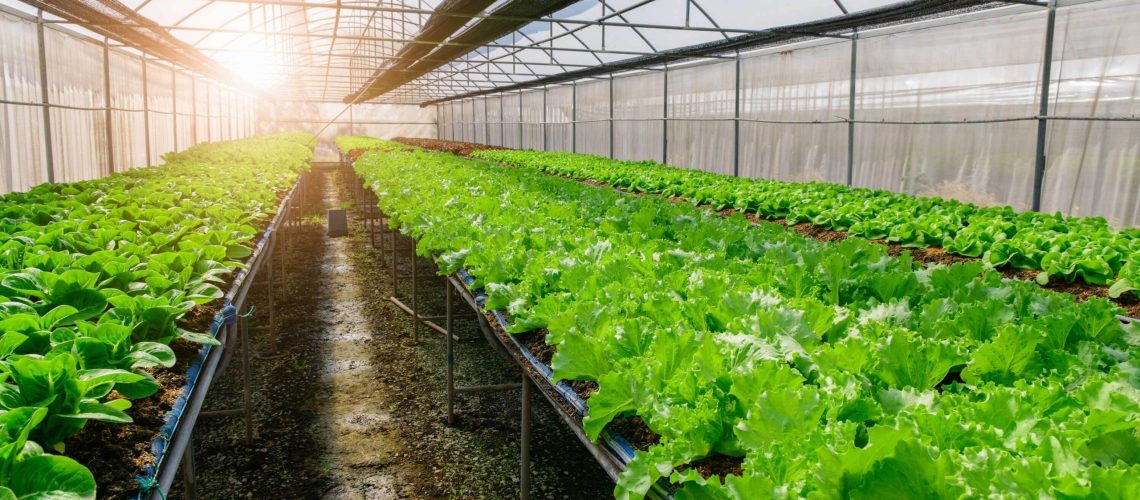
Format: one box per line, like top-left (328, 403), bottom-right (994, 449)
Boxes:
top-left (43, 30), bottom-right (108, 182)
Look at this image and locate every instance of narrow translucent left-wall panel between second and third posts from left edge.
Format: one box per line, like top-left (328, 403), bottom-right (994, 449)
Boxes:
top-left (111, 50), bottom-right (147, 172)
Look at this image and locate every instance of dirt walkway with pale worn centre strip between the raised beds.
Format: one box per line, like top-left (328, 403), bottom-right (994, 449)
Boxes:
top-left (182, 166), bottom-right (612, 500)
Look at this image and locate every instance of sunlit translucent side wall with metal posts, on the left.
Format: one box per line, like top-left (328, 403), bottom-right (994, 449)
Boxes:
top-left (0, 6), bottom-right (255, 195)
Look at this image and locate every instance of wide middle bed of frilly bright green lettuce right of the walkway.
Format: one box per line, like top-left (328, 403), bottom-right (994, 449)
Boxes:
top-left (356, 140), bottom-right (1140, 499)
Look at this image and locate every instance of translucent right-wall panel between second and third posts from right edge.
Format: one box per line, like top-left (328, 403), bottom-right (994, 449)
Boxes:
top-left (740, 42), bottom-right (850, 183)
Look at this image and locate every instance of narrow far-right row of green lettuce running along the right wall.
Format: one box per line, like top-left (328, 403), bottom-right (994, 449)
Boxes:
top-left (472, 150), bottom-right (1140, 297)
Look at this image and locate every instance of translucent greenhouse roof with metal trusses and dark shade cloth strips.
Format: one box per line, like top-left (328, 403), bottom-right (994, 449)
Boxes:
top-left (0, 0), bottom-right (1044, 104)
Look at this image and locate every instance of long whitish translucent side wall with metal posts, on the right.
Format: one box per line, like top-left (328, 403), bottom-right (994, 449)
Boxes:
top-left (437, 0), bottom-right (1140, 226)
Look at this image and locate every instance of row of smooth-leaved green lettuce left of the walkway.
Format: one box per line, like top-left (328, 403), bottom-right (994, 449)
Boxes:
top-left (0, 133), bottom-right (314, 499)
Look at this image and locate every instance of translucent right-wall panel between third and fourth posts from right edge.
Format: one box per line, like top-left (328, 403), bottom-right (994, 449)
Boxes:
top-left (666, 62), bottom-right (736, 175)
